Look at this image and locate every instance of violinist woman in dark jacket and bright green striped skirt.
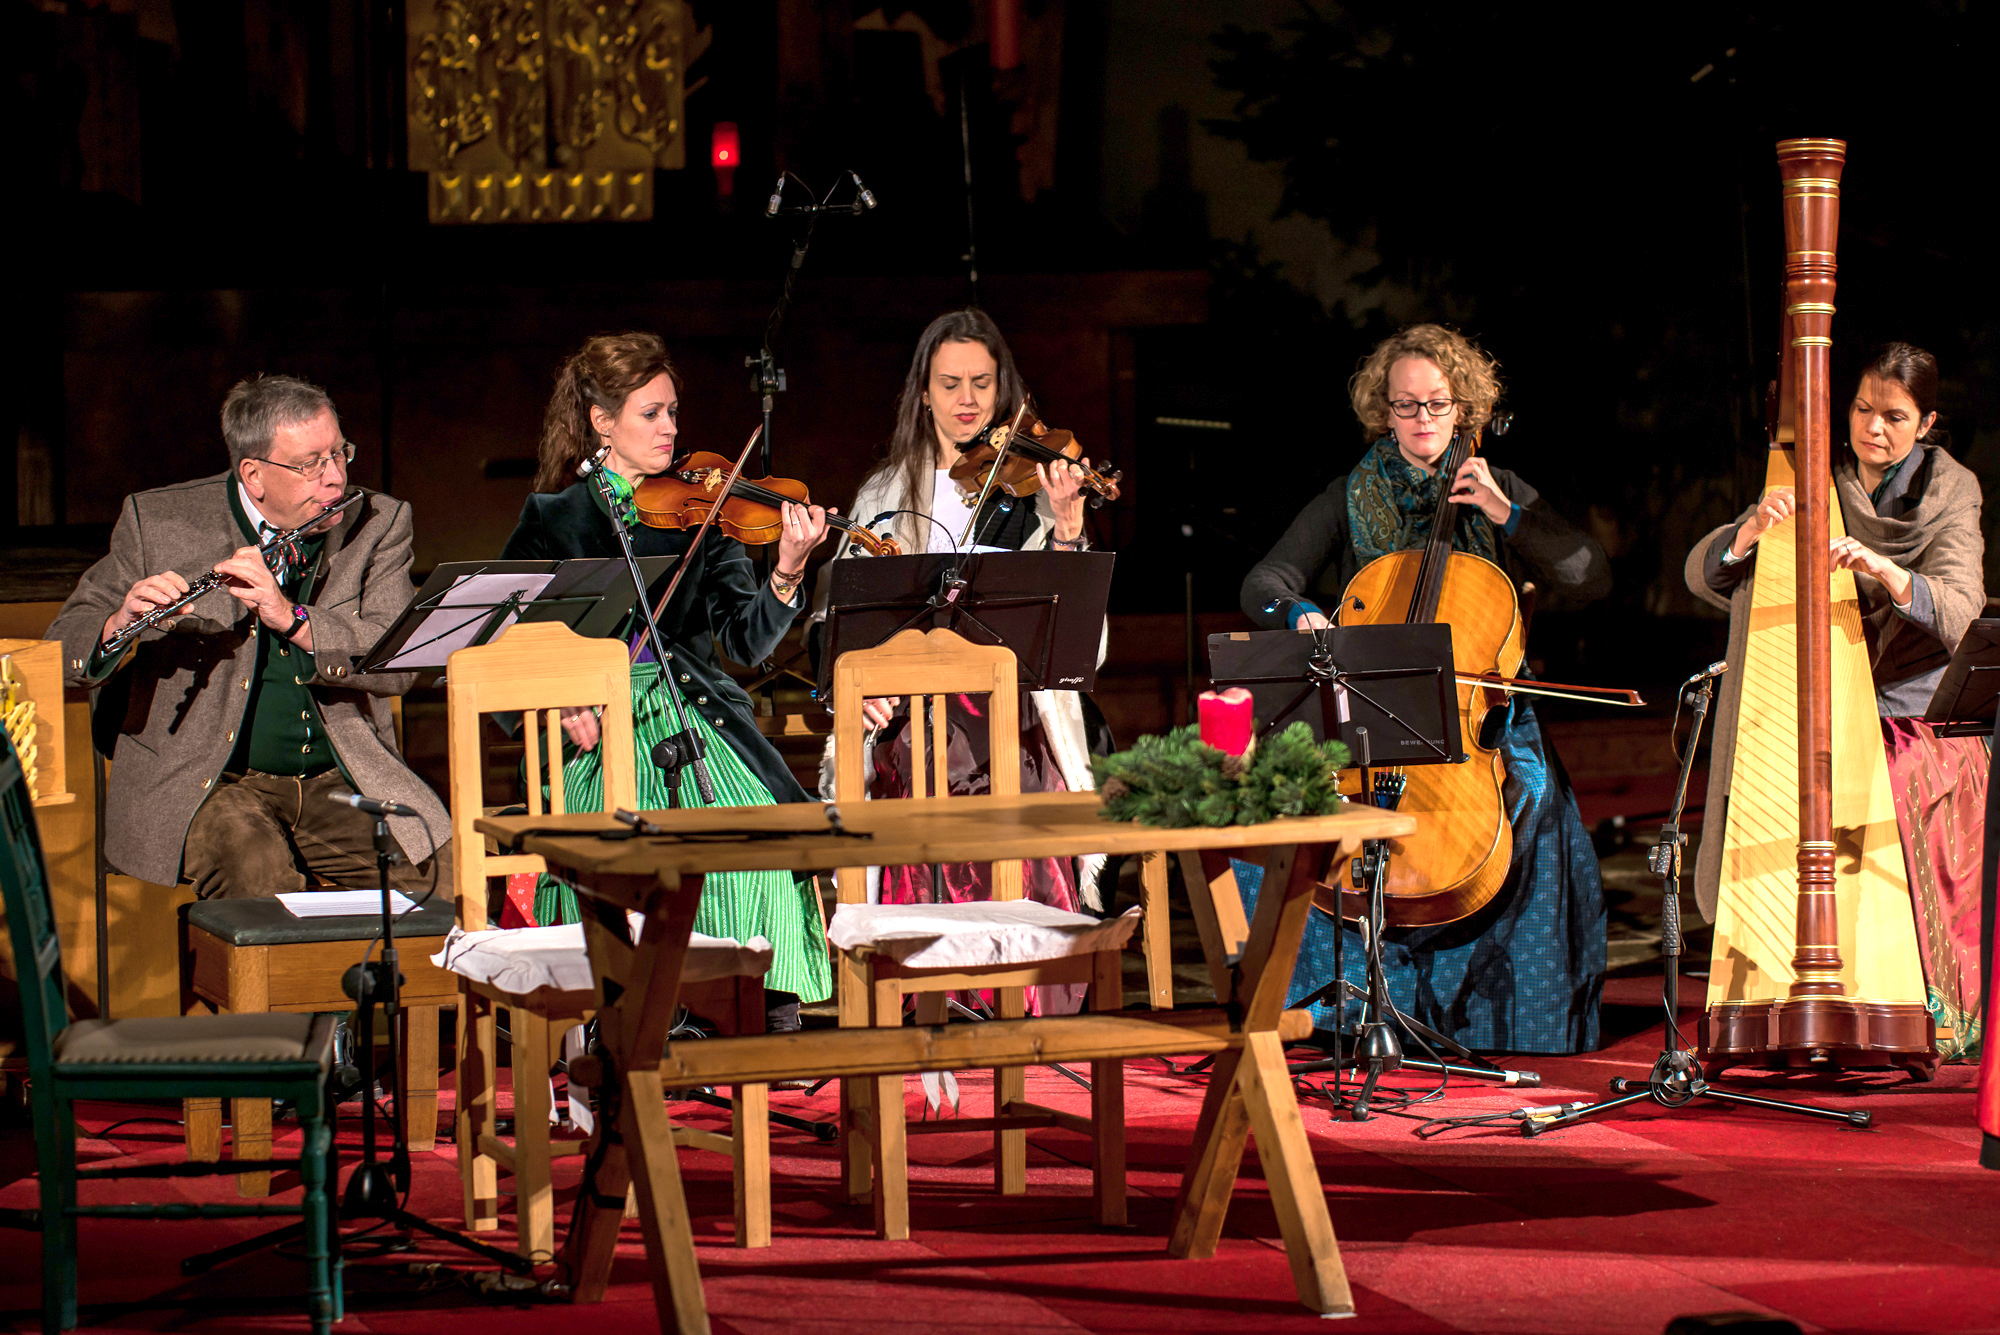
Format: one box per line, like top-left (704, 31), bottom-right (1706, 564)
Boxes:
top-left (500, 334), bottom-right (832, 1029)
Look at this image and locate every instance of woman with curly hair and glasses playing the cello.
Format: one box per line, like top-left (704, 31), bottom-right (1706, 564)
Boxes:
top-left (1238, 324), bottom-right (1610, 1053)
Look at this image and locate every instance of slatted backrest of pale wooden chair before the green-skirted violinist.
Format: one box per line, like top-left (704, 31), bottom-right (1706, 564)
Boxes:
top-left (444, 622), bottom-right (638, 931)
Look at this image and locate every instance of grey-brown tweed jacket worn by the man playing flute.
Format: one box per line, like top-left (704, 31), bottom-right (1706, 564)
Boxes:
top-left (48, 474), bottom-right (450, 885)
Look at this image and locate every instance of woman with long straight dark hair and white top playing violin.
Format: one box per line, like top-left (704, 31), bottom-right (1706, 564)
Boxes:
top-left (816, 310), bottom-right (1102, 939)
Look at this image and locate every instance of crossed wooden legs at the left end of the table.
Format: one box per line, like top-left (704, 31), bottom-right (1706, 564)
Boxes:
top-left (564, 875), bottom-right (708, 1331)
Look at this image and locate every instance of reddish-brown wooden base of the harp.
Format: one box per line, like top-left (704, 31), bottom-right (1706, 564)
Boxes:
top-left (1700, 997), bottom-right (1938, 1081)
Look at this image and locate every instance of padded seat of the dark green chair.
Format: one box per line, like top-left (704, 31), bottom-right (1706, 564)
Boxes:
top-left (56, 1013), bottom-right (334, 1075)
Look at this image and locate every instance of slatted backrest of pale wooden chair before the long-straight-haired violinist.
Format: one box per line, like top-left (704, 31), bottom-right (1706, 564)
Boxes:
top-left (834, 630), bottom-right (1020, 903)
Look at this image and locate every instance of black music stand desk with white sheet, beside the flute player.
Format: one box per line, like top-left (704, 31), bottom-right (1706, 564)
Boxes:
top-left (354, 556), bottom-right (680, 671)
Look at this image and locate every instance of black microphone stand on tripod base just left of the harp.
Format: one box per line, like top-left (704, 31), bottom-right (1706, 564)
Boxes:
top-left (1520, 664), bottom-right (1874, 1135)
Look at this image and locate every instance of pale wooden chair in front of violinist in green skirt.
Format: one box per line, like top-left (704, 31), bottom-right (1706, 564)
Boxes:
top-left (446, 622), bottom-right (770, 1261)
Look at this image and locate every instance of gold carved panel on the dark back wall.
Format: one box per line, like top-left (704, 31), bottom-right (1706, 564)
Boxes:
top-left (406, 0), bottom-right (710, 222)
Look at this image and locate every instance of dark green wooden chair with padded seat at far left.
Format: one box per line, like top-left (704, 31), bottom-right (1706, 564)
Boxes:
top-left (0, 737), bottom-right (340, 1331)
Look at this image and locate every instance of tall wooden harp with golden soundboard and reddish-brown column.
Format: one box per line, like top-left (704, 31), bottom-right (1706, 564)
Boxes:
top-left (1700, 140), bottom-right (1936, 1077)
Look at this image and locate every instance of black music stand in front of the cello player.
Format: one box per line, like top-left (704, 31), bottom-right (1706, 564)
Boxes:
top-left (1208, 622), bottom-right (1542, 1121)
